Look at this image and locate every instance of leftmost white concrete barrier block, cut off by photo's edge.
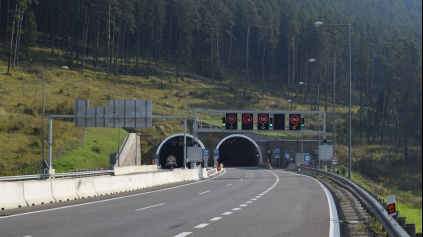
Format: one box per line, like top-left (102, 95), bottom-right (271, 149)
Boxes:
top-left (0, 182), bottom-right (28, 210)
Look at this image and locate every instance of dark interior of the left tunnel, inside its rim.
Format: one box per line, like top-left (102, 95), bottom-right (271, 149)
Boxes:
top-left (159, 136), bottom-right (193, 169)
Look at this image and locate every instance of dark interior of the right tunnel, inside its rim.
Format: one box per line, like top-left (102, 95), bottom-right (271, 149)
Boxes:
top-left (219, 137), bottom-right (259, 167)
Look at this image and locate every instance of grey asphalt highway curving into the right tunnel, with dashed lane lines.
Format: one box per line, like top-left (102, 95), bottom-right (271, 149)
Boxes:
top-left (0, 168), bottom-right (331, 237)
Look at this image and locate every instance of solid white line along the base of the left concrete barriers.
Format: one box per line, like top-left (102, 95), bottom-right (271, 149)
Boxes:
top-left (0, 169), bottom-right (226, 219)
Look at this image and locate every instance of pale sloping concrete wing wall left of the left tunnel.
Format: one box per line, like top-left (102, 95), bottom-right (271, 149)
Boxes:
top-left (114, 133), bottom-right (141, 167)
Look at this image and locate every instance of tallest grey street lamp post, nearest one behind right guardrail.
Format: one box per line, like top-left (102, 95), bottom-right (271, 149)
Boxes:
top-left (314, 21), bottom-right (352, 180)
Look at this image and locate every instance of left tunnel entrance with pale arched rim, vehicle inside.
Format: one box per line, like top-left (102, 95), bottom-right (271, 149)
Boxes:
top-left (156, 134), bottom-right (204, 169)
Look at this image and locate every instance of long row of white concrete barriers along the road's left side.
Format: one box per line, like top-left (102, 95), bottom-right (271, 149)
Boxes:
top-left (0, 169), bottom-right (209, 210)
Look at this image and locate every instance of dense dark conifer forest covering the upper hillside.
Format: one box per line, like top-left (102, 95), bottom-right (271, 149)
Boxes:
top-left (0, 0), bottom-right (422, 172)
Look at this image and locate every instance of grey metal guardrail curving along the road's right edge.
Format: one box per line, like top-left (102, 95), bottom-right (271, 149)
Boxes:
top-left (300, 167), bottom-right (410, 237)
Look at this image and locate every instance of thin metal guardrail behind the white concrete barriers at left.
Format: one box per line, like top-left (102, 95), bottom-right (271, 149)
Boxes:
top-left (0, 170), bottom-right (114, 182)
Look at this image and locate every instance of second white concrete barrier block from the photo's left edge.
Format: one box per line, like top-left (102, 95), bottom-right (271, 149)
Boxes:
top-left (23, 180), bottom-right (56, 206)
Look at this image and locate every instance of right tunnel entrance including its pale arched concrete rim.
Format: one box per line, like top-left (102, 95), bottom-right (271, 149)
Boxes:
top-left (216, 134), bottom-right (263, 167)
